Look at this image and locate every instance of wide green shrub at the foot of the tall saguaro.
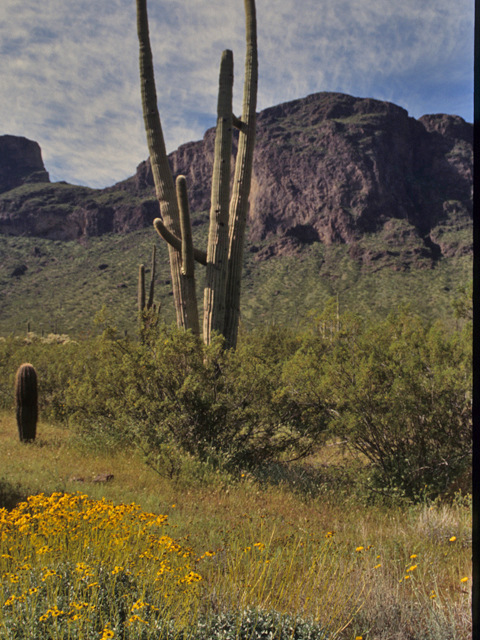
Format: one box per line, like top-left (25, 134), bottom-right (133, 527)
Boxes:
top-left (61, 325), bottom-right (324, 469)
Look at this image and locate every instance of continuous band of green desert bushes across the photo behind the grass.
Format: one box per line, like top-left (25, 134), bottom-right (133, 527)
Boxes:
top-left (0, 302), bottom-right (472, 500)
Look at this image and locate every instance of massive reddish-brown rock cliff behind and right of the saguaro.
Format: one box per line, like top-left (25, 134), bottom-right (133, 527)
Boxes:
top-left (155, 93), bottom-right (473, 257)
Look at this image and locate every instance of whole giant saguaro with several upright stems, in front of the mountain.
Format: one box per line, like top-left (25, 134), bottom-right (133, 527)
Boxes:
top-left (136, 0), bottom-right (258, 348)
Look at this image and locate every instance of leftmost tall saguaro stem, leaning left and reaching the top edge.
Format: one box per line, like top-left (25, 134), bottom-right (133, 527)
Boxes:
top-left (136, 0), bottom-right (196, 329)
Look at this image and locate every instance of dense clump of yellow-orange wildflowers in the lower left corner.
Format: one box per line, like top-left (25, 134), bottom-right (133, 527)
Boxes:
top-left (0, 493), bottom-right (202, 638)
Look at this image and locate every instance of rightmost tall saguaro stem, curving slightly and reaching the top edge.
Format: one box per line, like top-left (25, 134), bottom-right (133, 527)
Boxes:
top-left (223, 0), bottom-right (258, 348)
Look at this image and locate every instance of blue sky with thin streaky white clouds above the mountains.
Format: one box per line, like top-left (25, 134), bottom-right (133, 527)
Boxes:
top-left (0, 0), bottom-right (474, 188)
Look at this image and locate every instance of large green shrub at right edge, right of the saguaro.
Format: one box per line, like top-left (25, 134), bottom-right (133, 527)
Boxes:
top-left (284, 307), bottom-right (472, 500)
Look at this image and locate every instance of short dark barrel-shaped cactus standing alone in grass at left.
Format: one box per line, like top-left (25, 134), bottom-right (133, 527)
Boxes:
top-left (15, 362), bottom-right (38, 442)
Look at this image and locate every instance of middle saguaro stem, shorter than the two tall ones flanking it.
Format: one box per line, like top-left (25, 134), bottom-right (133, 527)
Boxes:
top-left (203, 49), bottom-right (233, 344)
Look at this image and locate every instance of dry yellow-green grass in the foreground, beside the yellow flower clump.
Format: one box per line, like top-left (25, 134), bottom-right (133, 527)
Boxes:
top-left (0, 413), bottom-right (471, 640)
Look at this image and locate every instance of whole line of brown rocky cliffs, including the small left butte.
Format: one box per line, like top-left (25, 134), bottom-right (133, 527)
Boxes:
top-left (0, 93), bottom-right (473, 270)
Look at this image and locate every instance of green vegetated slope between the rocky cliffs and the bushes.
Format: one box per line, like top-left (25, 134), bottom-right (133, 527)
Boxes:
top-left (0, 229), bottom-right (472, 337)
